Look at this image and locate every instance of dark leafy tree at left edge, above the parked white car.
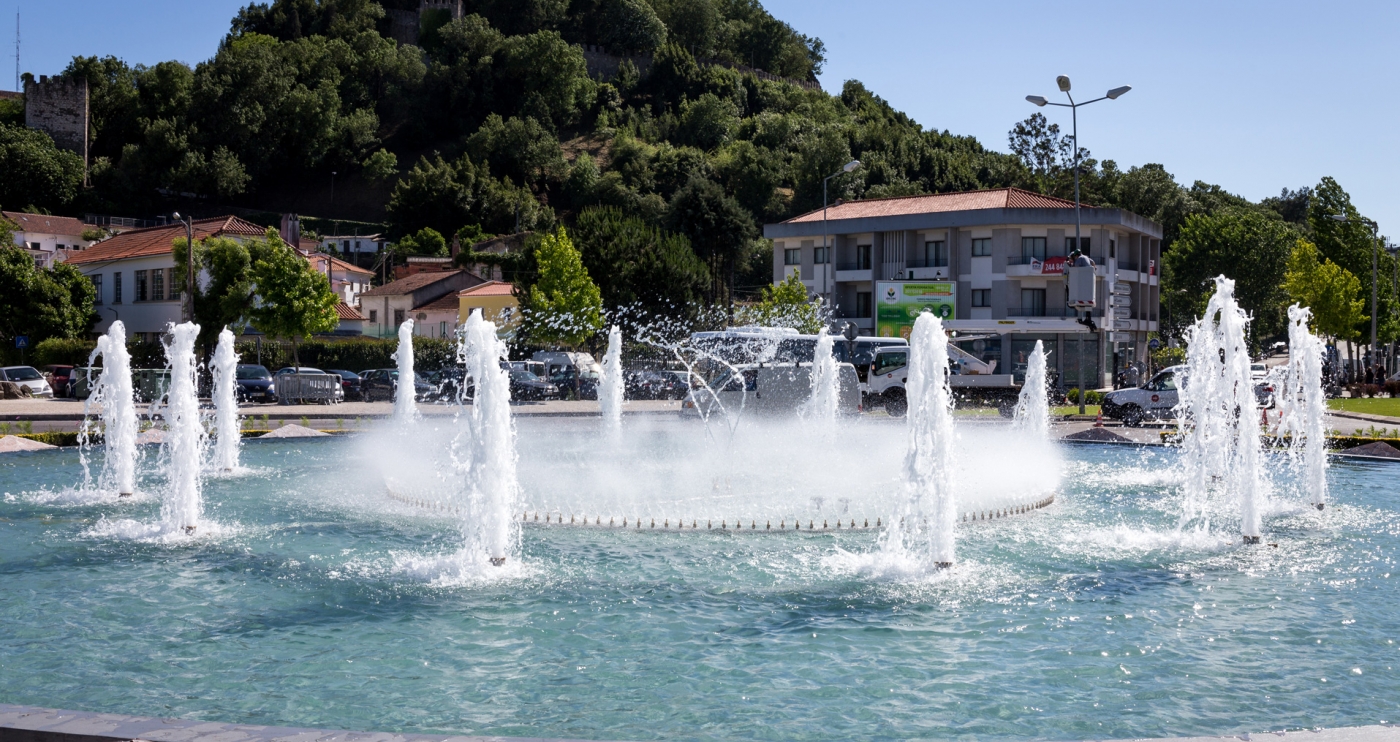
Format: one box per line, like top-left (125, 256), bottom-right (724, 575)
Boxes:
top-left (0, 220), bottom-right (98, 354)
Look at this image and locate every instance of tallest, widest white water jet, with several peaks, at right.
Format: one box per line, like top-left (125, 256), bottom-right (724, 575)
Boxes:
top-left (1176, 276), bottom-right (1266, 543)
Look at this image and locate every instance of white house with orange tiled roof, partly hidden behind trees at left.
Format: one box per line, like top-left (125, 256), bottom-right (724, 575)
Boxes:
top-left (67, 216), bottom-right (267, 340)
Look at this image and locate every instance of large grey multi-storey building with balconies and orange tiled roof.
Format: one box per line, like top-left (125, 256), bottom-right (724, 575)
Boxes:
top-left (763, 189), bottom-right (1162, 386)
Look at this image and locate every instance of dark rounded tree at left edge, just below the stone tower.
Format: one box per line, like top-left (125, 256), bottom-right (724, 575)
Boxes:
top-left (0, 123), bottom-right (83, 207)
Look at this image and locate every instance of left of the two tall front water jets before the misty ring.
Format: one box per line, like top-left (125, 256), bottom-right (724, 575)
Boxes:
top-left (458, 309), bottom-right (519, 567)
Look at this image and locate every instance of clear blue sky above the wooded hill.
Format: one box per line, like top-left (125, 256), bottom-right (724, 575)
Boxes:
top-left (0, 0), bottom-right (1400, 234)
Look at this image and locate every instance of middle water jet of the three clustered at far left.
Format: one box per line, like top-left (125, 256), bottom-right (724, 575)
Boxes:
top-left (161, 322), bottom-right (204, 533)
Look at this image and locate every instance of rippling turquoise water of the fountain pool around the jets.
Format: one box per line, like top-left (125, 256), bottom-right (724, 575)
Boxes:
top-left (0, 423), bottom-right (1400, 739)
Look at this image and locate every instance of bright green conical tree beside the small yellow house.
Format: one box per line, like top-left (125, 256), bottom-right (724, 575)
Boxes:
top-left (526, 227), bottom-right (603, 347)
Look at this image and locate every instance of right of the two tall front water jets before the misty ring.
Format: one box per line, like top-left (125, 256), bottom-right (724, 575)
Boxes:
top-left (882, 312), bottom-right (956, 568)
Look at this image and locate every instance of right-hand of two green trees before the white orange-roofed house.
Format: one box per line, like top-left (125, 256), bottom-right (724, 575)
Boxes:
top-left (248, 230), bottom-right (340, 367)
